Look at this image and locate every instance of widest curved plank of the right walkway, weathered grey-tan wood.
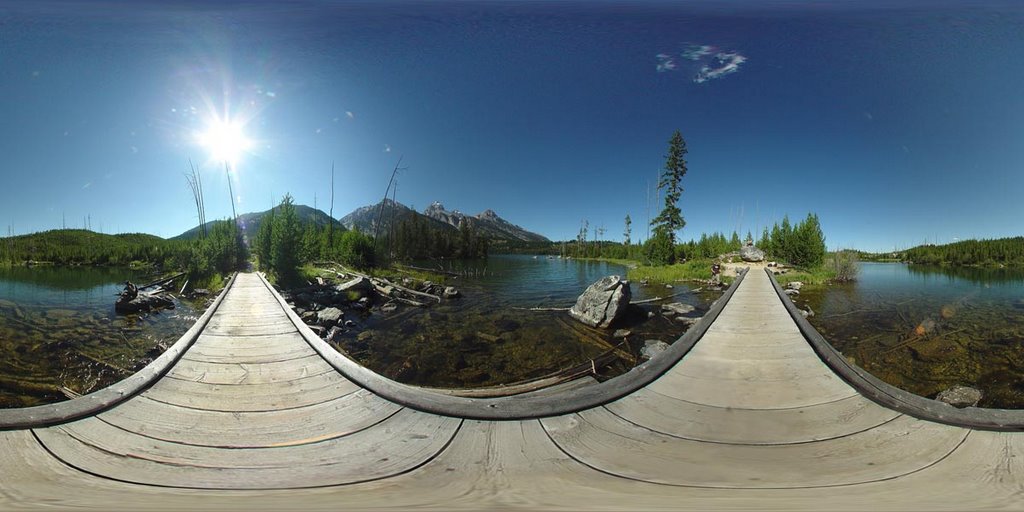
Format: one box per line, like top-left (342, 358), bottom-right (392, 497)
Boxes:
top-left (541, 409), bottom-right (968, 488)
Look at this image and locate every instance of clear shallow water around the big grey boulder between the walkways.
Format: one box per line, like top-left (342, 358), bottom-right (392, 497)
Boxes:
top-left (338, 255), bottom-right (721, 387)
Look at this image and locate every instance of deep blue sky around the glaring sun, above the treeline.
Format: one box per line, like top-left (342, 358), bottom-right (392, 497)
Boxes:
top-left (0, 1), bottom-right (1024, 250)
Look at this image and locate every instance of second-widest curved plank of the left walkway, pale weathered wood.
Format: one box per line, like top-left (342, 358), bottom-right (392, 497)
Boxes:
top-left (96, 390), bottom-right (401, 447)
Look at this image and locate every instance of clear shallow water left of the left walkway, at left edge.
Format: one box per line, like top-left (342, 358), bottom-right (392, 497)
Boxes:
top-left (0, 266), bottom-right (197, 408)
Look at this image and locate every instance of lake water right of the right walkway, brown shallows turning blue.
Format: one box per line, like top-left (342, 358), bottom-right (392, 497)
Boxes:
top-left (797, 263), bottom-right (1024, 409)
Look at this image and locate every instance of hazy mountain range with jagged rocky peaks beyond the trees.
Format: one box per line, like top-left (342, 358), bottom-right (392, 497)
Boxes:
top-left (172, 199), bottom-right (550, 242)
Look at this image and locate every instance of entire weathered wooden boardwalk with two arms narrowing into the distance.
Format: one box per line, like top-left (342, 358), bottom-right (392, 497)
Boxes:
top-left (0, 269), bottom-right (1024, 510)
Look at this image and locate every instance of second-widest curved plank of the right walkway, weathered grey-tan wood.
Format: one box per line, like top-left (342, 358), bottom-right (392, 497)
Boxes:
top-left (605, 388), bottom-right (900, 444)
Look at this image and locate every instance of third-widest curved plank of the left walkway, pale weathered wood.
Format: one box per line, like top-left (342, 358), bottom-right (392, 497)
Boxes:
top-left (136, 372), bottom-right (361, 413)
